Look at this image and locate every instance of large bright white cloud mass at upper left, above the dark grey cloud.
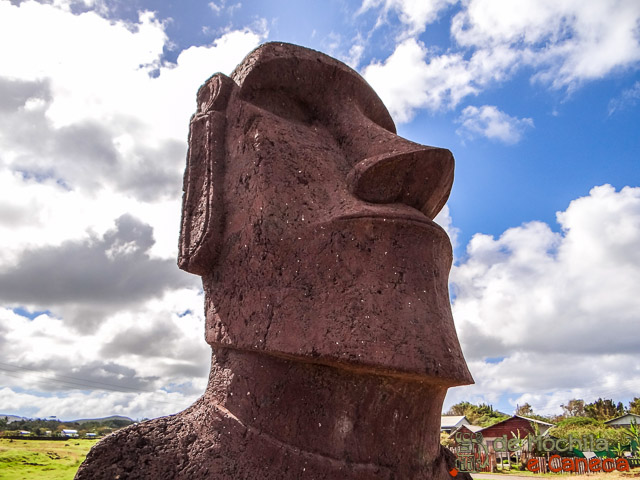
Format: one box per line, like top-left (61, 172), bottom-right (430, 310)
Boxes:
top-left (0, 0), bottom-right (265, 258)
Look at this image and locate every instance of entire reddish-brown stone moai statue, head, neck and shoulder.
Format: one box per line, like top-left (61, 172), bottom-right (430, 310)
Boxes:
top-left (76, 43), bottom-right (473, 480)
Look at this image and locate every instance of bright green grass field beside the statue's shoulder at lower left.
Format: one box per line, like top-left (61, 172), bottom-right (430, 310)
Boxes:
top-left (0, 438), bottom-right (97, 480)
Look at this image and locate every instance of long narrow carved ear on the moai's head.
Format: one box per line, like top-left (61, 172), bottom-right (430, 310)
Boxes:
top-left (178, 73), bottom-right (237, 275)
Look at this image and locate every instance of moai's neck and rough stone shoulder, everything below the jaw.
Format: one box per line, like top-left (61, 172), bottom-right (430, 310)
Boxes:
top-left (76, 350), bottom-right (470, 480)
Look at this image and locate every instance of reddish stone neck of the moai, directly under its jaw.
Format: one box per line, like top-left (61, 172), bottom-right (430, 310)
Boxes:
top-left (203, 347), bottom-right (446, 468)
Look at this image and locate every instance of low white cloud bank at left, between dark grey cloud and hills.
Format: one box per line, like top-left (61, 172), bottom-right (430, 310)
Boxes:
top-left (0, 289), bottom-right (211, 418)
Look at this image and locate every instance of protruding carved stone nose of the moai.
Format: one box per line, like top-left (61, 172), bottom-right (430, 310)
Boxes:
top-left (347, 144), bottom-right (454, 220)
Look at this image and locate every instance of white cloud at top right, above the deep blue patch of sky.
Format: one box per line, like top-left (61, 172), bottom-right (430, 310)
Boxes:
top-left (361, 0), bottom-right (640, 123)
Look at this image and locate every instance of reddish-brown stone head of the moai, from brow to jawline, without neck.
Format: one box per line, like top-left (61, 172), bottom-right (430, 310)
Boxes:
top-left (178, 43), bottom-right (472, 386)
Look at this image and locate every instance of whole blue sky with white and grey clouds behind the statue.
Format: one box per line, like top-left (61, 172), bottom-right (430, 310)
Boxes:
top-left (0, 0), bottom-right (640, 419)
